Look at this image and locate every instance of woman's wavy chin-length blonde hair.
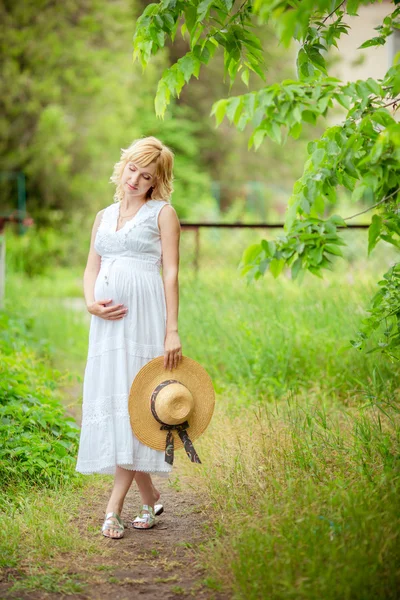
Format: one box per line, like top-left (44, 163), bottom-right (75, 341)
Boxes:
top-left (110, 135), bottom-right (174, 203)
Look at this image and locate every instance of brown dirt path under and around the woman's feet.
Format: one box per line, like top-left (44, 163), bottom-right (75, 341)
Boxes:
top-left (59, 477), bottom-right (226, 600)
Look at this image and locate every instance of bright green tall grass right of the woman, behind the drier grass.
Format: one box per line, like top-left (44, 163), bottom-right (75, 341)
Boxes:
top-left (179, 272), bottom-right (399, 405)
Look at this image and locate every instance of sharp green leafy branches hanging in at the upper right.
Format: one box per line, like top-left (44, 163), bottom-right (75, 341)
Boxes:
top-left (133, 0), bottom-right (400, 359)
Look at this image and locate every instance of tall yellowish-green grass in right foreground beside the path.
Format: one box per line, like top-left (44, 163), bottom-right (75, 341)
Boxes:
top-left (186, 398), bottom-right (400, 600)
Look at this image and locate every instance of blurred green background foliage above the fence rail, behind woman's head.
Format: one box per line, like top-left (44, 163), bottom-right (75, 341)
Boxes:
top-left (0, 0), bottom-right (318, 274)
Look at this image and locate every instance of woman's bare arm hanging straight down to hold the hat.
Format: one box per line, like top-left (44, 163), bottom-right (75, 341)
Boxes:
top-left (158, 205), bottom-right (182, 369)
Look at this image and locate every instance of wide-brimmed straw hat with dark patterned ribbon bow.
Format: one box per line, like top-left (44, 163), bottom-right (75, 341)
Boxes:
top-left (128, 356), bottom-right (215, 465)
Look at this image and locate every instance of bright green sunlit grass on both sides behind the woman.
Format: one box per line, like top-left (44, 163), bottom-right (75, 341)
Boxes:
top-left (7, 267), bottom-right (399, 404)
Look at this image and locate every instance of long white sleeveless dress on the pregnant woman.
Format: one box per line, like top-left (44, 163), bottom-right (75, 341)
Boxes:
top-left (75, 200), bottom-right (172, 477)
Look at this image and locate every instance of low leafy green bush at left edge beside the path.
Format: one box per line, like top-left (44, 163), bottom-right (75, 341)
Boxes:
top-left (0, 312), bottom-right (79, 487)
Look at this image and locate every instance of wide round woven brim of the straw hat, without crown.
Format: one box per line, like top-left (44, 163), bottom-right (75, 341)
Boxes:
top-left (128, 356), bottom-right (215, 450)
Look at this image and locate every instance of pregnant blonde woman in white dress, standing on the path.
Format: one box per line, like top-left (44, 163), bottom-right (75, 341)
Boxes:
top-left (76, 136), bottom-right (182, 538)
